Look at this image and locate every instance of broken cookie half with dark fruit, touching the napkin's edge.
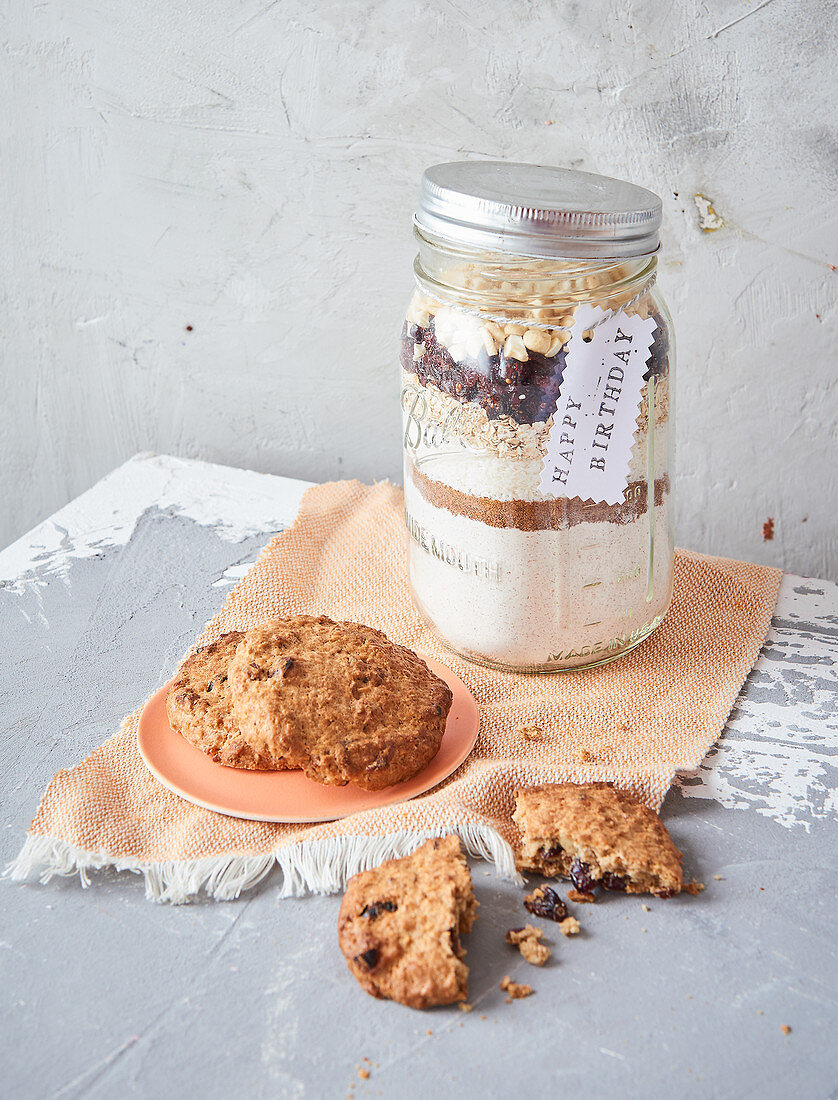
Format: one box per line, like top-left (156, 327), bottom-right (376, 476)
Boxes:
top-left (512, 783), bottom-right (683, 898)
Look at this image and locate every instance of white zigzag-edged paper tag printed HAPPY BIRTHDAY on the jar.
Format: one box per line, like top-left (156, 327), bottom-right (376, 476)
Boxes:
top-left (540, 305), bottom-right (658, 504)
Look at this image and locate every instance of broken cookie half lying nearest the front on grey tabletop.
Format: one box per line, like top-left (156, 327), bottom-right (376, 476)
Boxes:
top-left (338, 836), bottom-right (477, 1009)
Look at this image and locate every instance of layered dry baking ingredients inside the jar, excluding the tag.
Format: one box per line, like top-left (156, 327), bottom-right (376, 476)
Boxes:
top-left (400, 260), bottom-right (672, 670)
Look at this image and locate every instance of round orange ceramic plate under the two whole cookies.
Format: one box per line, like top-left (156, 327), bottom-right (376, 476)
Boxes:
top-left (137, 660), bottom-right (478, 823)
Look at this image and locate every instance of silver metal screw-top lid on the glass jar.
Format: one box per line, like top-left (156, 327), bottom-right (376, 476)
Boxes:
top-left (414, 161), bottom-right (661, 260)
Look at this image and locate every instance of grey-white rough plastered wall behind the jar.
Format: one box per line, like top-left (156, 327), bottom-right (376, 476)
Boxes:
top-left (0, 0), bottom-right (838, 576)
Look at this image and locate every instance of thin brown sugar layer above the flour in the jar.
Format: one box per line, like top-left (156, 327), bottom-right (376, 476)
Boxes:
top-left (409, 463), bottom-right (670, 531)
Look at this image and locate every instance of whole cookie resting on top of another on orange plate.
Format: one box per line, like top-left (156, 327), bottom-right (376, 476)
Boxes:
top-left (229, 615), bottom-right (452, 791)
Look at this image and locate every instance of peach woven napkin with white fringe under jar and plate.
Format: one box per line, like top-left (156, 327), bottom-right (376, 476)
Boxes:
top-left (8, 482), bottom-right (781, 902)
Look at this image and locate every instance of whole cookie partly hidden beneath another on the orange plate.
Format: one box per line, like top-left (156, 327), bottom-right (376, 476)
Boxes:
top-left (166, 630), bottom-right (288, 770)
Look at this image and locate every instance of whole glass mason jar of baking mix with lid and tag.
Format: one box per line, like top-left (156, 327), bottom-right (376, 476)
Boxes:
top-left (400, 162), bottom-right (674, 672)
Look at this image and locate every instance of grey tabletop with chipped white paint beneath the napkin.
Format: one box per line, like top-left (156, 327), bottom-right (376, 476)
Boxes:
top-left (0, 455), bottom-right (838, 1100)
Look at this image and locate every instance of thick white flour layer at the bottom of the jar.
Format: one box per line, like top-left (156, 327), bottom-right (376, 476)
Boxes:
top-left (405, 477), bottom-right (672, 668)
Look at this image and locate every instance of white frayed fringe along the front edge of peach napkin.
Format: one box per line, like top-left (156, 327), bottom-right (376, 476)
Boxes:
top-left (3, 825), bottom-right (521, 905)
